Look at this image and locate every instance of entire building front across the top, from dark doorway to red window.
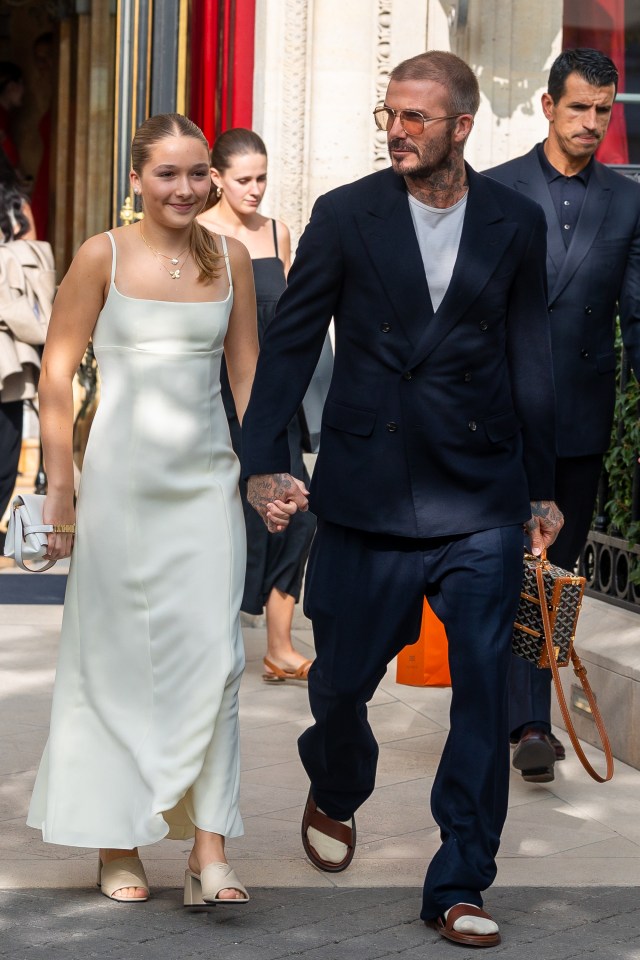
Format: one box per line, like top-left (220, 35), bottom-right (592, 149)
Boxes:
top-left (0, 0), bottom-right (640, 258)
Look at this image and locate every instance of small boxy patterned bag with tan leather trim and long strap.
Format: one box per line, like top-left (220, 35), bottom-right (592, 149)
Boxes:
top-left (513, 553), bottom-right (613, 783)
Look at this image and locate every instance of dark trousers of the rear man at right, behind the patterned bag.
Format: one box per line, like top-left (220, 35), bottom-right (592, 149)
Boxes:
top-left (509, 454), bottom-right (602, 736)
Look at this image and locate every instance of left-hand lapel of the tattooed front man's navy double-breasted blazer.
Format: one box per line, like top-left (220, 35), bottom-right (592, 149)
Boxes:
top-left (356, 170), bottom-right (433, 347)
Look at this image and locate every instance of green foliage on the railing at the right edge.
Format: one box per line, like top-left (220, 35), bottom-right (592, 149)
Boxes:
top-left (604, 318), bottom-right (640, 583)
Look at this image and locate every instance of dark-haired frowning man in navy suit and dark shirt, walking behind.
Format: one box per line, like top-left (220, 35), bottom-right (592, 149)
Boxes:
top-left (487, 49), bottom-right (640, 783)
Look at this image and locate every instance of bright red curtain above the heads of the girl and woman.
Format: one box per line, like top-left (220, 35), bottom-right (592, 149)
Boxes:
top-left (189, 0), bottom-right (255, 144)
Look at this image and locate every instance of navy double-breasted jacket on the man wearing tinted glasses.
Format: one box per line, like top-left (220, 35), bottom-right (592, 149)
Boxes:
top-left (242, 169), bottom-right (555, 537)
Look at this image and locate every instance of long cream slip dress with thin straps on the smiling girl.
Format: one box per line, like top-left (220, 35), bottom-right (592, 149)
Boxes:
top-left (27, 233), bottom-right (246, 849)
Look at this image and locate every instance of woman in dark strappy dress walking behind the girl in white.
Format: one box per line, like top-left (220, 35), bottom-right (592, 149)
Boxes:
top-left (199, 128), bottom-right (315, 682)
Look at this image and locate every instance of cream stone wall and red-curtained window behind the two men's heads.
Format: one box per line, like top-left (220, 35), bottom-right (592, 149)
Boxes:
top-left (253, 0), bottom-right (640, 246)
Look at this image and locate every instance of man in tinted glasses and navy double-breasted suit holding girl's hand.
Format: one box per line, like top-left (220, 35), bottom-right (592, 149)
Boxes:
top-left (243, 51), bottom-right (562, 946)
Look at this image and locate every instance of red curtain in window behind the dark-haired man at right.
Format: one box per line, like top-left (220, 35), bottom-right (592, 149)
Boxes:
top-left (562, 0), bottom-right (629, 163)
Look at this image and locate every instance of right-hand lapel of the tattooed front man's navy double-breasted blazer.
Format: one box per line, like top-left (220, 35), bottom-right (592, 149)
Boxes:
top-left (410, 166), bottom-right (515, 366)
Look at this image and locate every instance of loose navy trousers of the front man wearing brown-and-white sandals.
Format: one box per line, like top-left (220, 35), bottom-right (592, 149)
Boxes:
top-left (298, 521), bottom-right (522, 920)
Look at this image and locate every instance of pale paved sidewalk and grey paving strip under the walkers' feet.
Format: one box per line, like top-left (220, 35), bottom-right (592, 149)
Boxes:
top-left (0, 588), bottom-right (640, 960)
